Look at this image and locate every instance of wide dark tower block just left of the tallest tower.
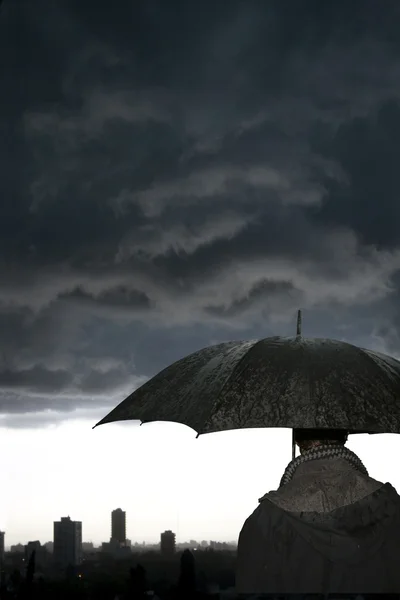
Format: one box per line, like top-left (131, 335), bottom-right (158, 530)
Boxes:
top-left (53, 517), bottom-right (82, 569)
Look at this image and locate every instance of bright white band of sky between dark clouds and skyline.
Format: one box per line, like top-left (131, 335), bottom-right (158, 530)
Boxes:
top-left (0, 418), bottom-right (400, 548)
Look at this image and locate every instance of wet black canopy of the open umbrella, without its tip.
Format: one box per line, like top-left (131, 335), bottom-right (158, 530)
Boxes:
top-left (96, 336), bottom-right (400, 434)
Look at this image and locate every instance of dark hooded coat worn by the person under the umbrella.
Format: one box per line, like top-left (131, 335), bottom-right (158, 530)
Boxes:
top-left (236, 458), bottom-right (400, 595)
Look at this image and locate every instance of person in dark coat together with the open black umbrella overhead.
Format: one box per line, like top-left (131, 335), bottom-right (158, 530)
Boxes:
top-left (95, 311), bottom-right (400, 594)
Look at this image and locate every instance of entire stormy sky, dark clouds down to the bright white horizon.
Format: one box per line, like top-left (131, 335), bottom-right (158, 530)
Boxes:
top-left (0, 0), bottom-right (400, 545)
